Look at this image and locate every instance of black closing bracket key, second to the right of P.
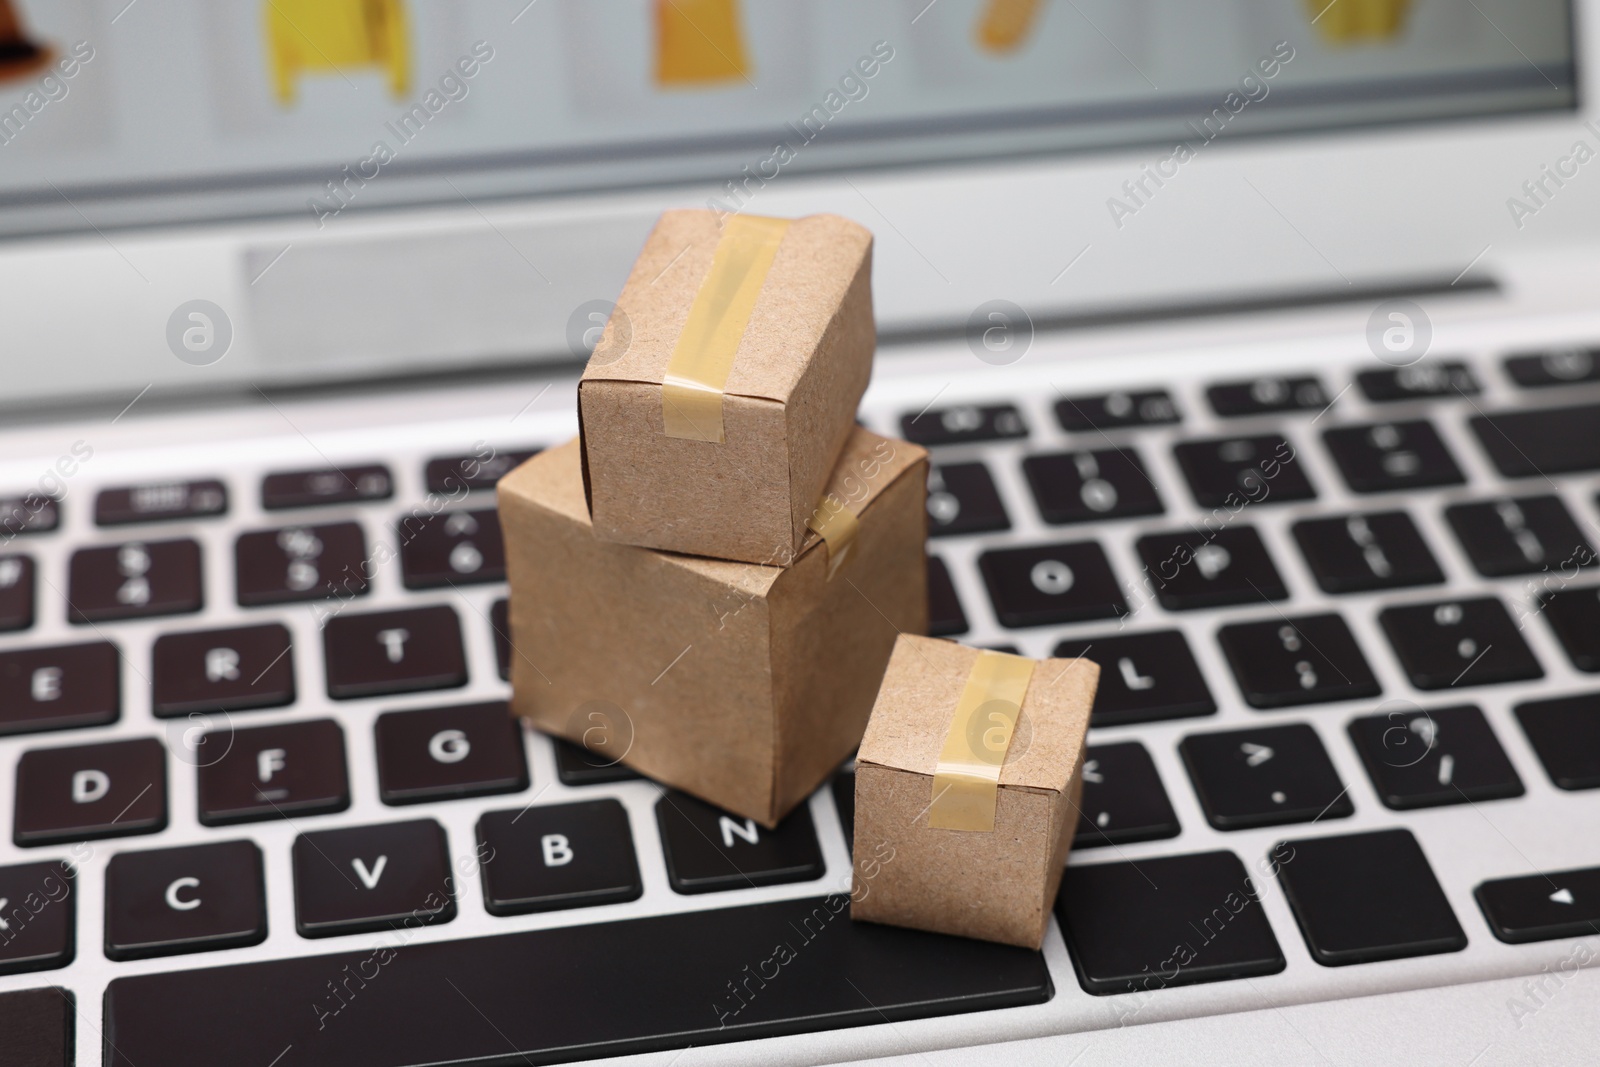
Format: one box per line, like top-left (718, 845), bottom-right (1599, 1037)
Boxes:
top-left (1445, 496), bottom-right (1597, 577)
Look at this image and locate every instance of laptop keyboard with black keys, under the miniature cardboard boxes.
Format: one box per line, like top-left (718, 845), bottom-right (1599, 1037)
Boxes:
top-left (0, 354), bottom-right (1600, 1067)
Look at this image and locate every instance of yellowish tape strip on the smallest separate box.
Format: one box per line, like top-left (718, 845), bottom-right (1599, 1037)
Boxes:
top-left (928, 649), bottom-right (1034, 833)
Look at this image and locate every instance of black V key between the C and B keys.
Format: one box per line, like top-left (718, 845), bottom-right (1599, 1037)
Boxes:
top-left (294, 819), bottom-right (456, 937)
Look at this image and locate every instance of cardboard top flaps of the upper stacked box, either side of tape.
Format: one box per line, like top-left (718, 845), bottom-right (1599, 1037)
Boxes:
top-left (579, 211), bottom-right (872, 403)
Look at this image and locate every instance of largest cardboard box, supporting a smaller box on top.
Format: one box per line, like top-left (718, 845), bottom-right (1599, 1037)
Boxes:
top-left (499, 429), bottom-right (928, 827)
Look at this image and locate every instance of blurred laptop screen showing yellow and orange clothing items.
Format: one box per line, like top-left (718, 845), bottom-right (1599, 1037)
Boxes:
top-left (0, 0), bottom-right (1576, 234)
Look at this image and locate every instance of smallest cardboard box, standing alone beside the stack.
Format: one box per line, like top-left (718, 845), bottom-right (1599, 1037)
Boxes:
top-left (851, 633), bottom-right (1099, 949)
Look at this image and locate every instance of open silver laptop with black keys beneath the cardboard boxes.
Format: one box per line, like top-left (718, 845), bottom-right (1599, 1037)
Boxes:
top-left (0, 0), bottom-right (1600, 1067)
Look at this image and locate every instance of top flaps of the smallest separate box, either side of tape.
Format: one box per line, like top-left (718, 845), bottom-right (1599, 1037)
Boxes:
top-left (856, 637), bottom-right (1099, 792)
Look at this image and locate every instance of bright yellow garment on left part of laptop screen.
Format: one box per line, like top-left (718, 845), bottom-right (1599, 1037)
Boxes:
top-left (266, 0), bottom-right (411, 104)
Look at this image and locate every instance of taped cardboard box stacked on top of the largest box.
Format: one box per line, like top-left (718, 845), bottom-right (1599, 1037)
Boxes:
top-left (578, 211), bottom-right (877, 563)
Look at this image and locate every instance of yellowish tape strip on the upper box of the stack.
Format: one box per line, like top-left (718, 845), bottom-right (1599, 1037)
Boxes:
top-left (661, 214), bottom-right (789, 445)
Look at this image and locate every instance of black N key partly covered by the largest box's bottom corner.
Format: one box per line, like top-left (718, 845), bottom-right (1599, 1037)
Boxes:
top-left (656, 790), bottom-right (822, 893)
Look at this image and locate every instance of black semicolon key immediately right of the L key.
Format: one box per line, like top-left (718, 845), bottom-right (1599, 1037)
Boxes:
top-left (1216, 614), bottom-right (1382, 707)
